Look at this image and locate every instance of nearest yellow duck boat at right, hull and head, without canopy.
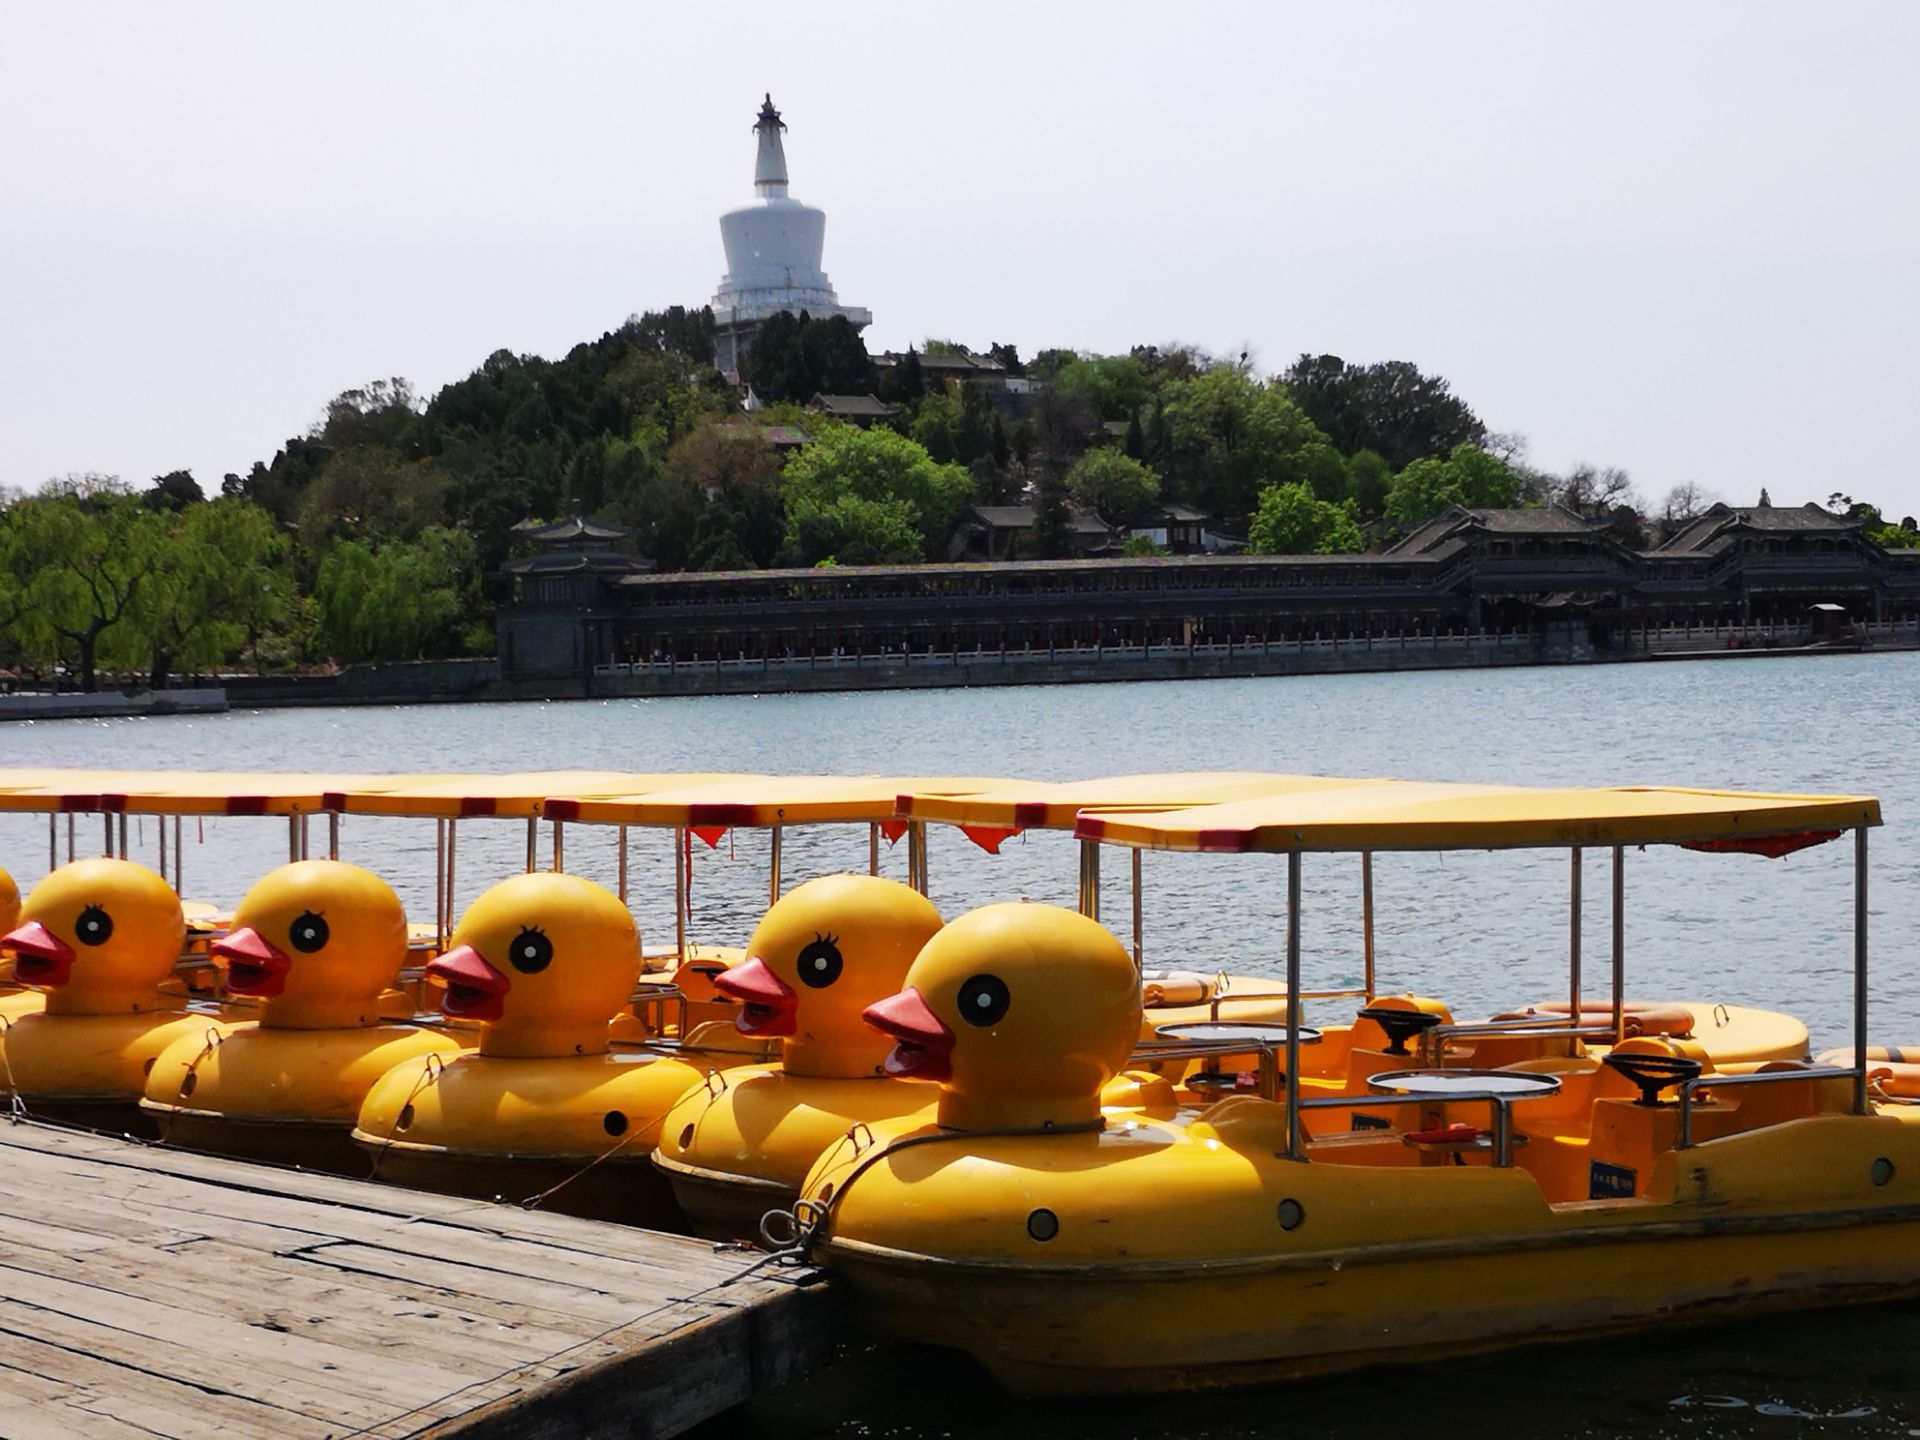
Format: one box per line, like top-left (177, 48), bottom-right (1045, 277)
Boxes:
top-left (797, 904), bottom-right (1920, 1394)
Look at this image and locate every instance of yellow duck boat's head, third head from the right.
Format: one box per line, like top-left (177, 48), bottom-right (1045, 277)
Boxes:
top-left (426, 872), bottom-right (641, 1058)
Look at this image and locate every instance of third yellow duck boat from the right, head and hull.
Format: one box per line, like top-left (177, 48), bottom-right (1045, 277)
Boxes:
top-left (353, 872), bottom-right (766, 1227)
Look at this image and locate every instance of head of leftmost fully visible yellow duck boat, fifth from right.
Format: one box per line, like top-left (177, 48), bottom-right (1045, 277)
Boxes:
top-left (0, 858), bottom-right (186, 1016)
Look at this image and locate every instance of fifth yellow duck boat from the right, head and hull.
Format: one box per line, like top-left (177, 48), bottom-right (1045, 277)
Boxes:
top-left (0, 858), bottom-right (213, 1135)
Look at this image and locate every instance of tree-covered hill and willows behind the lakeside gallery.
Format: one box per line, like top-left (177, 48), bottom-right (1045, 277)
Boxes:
top-left (0, 307), bottom-right (1920, 687)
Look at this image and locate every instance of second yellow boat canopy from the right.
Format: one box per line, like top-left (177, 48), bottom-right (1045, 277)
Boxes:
top-left (897, 770), bottom-right (1356, 829)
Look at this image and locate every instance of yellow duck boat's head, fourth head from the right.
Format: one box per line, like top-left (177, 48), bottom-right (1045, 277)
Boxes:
top-left (213, 860), bottom-right (407, 1029)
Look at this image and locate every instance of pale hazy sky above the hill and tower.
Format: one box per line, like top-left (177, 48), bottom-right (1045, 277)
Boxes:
top-left (0, 0), bottom-right (1920, 515)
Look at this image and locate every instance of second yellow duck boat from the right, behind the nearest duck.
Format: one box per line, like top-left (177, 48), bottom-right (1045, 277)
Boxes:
top-left (655, 876), bottom-right (941, 1238)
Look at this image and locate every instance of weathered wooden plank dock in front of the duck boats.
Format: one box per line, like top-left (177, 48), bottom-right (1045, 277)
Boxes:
top-left (0, 1121), bottom-right (841, 1440)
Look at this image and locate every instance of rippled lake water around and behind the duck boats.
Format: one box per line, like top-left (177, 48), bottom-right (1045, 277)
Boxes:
top-left (0, 655), bottom-right (1920, 1440)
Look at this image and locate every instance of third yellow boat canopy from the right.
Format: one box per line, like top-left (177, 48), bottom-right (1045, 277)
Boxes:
top-left (545, 776), bottom-right (1012, 828)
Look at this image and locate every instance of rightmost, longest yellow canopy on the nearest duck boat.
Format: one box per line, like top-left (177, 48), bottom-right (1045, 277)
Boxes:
top-left (1073, 780), bottom-right (1880, 852)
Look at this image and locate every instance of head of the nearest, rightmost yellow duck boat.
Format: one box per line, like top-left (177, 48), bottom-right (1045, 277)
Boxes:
top-left (866, 902), bottom-right (1140, 1131)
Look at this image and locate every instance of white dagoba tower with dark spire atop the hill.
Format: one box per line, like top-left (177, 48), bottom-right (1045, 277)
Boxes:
top-left (712, 94), bottom-right (874, 380)
